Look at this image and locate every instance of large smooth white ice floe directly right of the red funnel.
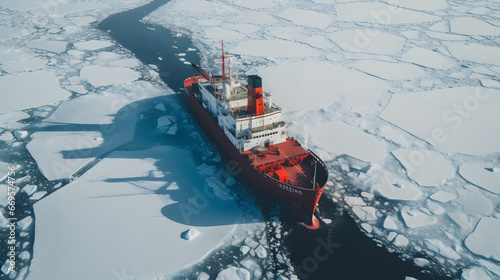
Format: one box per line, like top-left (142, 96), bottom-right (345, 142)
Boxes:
top-left (259, 61), bottom-right (386, 114)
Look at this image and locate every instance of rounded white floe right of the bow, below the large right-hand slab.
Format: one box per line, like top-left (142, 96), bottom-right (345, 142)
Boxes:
top-left (392, 149), bottom-right (455, 186)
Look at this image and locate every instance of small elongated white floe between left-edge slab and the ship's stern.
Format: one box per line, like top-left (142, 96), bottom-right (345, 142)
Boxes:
top-left (80, 66), bottom-right (141, 87)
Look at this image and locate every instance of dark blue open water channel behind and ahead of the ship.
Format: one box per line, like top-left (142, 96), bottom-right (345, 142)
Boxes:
top-left (99, 0), bottom-right (455, 280)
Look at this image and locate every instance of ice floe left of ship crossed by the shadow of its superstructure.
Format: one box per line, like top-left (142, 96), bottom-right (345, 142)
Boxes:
top-left (26, 86), bottom-right (164, 180)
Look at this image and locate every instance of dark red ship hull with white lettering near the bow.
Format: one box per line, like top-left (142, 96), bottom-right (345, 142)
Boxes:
top-left (184, 76), bottom-right (328, 228)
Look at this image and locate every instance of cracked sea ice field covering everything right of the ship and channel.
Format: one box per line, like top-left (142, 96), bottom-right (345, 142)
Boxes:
top-left (146, 0), bottom-right (500, 279)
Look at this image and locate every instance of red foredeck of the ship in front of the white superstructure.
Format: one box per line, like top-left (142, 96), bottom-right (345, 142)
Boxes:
top-left (242, 138), bottom-right (314, 189)
